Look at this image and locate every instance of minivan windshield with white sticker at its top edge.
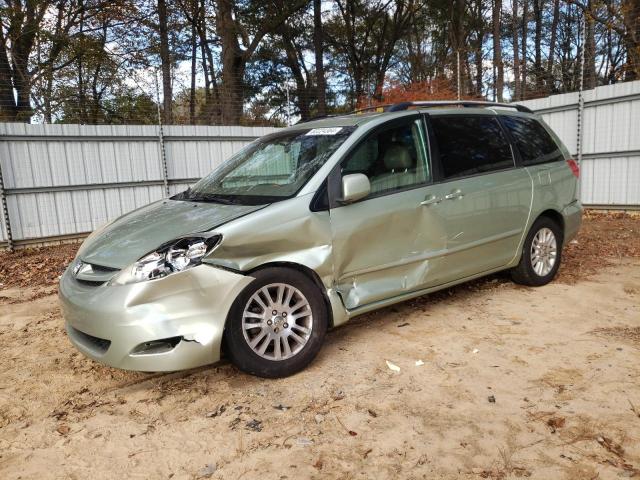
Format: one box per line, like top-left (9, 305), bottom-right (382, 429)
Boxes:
top-left (173, 127), bottom-right (354, 205)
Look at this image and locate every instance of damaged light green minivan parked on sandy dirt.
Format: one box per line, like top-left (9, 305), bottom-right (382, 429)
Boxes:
top-left (60, 102), bottom-right (582, 377)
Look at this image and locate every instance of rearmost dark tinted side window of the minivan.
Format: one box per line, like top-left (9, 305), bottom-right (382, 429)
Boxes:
top-left (502, 115), bottom-right (564, 165)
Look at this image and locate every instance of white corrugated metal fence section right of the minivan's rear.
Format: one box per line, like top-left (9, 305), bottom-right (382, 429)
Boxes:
top-left (518, 81), bottom-right (640, 207)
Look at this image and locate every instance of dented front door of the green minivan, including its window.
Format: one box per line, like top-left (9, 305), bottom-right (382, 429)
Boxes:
top-left (330, 115), bottom-right (446, 309)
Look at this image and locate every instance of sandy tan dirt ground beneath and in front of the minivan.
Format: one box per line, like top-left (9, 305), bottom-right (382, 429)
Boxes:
top-left (0, 215), bottom-right (640, 480)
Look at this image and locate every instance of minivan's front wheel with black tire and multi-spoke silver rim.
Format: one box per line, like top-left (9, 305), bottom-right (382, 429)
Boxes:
top-left (225, 267), bottom-right (328, 378)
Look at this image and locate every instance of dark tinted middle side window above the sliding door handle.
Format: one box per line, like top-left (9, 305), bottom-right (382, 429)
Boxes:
top-left (431, 115), bottom-right (514, 179)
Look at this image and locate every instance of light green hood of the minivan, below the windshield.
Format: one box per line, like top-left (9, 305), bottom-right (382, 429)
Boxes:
top-left (78, 200), bottom-right (264, 269)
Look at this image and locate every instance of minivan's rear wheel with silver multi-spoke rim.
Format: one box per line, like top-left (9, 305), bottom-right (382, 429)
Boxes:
top-left (511, 217), bottom-right (563, 287)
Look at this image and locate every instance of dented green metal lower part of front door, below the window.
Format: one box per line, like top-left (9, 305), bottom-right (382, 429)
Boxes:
top-left (324, 186), bottom-right (446, 309)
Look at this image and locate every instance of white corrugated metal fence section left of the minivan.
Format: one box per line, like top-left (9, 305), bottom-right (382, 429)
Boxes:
top-left (0, 123), bottom-right (276, 241)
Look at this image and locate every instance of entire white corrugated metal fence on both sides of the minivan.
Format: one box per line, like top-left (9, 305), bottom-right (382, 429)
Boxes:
top-left (0, 81), bottom-right (640, 245)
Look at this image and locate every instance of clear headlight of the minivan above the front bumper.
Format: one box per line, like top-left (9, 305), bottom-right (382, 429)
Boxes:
top-left (109, 235), bottom-right (221, 285)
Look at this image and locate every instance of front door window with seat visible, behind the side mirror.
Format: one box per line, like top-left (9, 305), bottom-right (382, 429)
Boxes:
top-left (341, 119), bottom-right (431, 194)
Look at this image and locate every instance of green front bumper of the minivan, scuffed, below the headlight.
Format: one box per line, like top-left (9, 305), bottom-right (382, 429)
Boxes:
top-left (59, 264), bottom-right (253, 372)
